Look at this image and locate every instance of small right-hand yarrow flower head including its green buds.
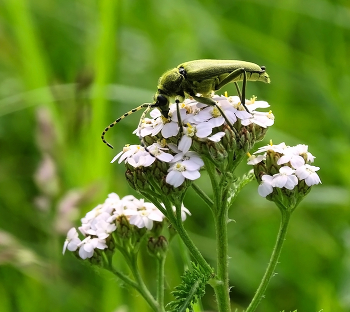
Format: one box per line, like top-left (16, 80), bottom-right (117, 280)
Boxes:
top-left (248, 143), bottom-right (321, 197)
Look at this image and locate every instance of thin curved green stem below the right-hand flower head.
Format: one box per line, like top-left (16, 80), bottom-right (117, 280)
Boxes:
top-left (246, 209), bottom-right (292, 312)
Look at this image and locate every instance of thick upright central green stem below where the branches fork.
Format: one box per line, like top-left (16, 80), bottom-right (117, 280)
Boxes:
top-left (214, 205), bottom-right (231, 312)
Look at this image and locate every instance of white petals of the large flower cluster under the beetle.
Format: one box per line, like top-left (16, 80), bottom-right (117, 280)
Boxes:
top-left (111, 95), bottom-right (274, 187)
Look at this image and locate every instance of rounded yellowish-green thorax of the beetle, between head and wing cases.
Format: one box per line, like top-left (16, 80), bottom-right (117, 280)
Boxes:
top-left (158, 68), bottom-right (184, 97)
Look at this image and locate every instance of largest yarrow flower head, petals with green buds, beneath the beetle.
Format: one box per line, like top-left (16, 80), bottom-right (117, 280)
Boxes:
top-left (112, 95), bottom-right (274, 188)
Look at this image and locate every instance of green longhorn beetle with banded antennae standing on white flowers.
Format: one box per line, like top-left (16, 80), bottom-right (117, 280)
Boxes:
top-left (101, 60), bottom-right (270, 148)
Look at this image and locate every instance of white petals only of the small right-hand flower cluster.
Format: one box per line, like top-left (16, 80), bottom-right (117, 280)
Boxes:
top-left (248, 143), bottom-right (321, 197)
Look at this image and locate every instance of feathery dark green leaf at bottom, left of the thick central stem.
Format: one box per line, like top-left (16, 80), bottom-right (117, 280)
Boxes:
top-left (167, 263), bottom-right (210, 312)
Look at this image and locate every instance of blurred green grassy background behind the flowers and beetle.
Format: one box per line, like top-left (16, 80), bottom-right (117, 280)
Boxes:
top-left (0, 0), bottom-right (350, 312)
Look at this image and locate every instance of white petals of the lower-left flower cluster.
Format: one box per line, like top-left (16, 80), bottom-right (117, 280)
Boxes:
top-left (63, 193), bottom-right (190, 259)
